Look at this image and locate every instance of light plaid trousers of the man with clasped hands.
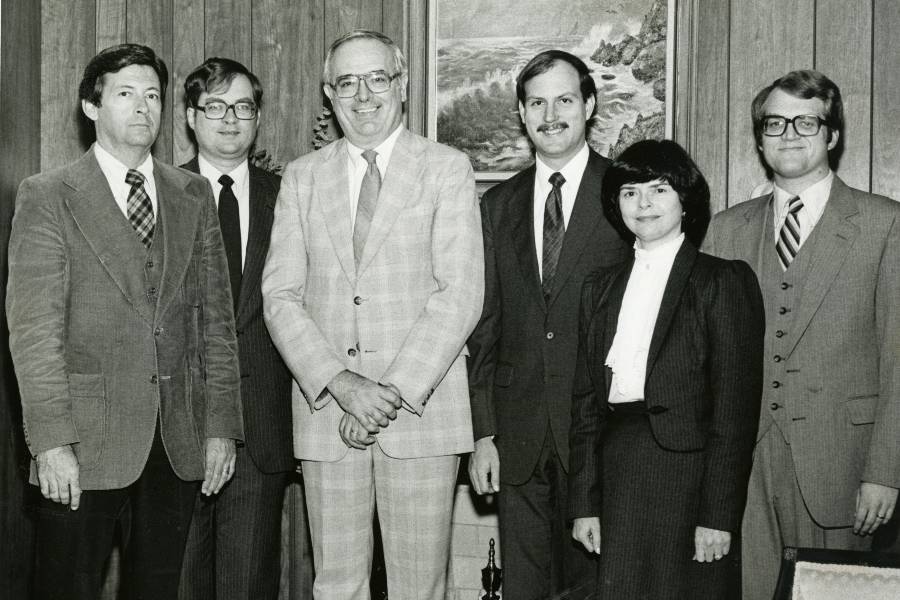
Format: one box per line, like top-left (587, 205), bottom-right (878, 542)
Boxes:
top-left (303, 442), bottom-right (459, 600)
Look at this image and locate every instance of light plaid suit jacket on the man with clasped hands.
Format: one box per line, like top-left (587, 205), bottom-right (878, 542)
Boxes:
top-left (262, 129), bottom-right (484, 461)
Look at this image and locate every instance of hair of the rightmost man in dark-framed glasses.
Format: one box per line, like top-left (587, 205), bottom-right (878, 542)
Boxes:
top-left (750, 69), bottom-right (844, 149)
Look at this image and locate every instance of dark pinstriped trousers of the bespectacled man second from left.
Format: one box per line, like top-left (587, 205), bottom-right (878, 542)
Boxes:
top-left (179, 447), bottom-right (288, 600)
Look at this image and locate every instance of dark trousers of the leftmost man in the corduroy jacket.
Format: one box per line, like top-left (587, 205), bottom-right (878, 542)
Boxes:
top-left (34, 427), bottom-right (197, 600)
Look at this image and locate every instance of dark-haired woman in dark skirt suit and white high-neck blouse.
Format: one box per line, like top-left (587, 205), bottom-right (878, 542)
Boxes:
top-left (569, 140), bottom-right (765, 600)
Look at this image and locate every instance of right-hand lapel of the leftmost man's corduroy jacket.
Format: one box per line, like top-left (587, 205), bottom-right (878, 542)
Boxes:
top-left (153, 159), bottom-right (205, 317)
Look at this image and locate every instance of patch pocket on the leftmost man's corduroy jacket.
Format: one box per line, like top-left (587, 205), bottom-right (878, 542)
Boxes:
top-left (68, 373), bottom-right (109, 469)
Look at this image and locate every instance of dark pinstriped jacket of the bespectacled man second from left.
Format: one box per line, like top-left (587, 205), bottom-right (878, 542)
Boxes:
top-left (182, 158), bottom-right (294, 473)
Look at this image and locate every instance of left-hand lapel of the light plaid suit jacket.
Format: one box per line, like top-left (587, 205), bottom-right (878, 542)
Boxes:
top-left (312, 138), bottom-right (356, 283)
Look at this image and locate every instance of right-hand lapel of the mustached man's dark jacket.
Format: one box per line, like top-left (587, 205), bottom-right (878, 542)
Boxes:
top-left (547, 152), bottom-right (603, 305)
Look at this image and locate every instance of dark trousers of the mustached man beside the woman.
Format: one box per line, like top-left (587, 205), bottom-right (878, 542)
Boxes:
top-left (498, 427), bottom-right (598, 600)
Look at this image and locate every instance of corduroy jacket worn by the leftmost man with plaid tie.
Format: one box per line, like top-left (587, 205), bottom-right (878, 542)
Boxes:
top-left (7, 149), bottom-right (243, 489)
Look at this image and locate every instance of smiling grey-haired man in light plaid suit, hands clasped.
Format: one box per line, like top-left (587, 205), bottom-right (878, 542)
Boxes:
top-left (262, 30), bottom-right (484, 600)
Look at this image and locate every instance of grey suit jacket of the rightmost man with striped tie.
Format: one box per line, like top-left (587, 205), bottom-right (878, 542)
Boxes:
top-left (704, 177), bottom-right (900, 527)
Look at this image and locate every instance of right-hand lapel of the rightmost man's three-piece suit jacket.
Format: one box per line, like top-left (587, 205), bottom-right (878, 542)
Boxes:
top-left (786, 177), bottom-right (860, 352)
